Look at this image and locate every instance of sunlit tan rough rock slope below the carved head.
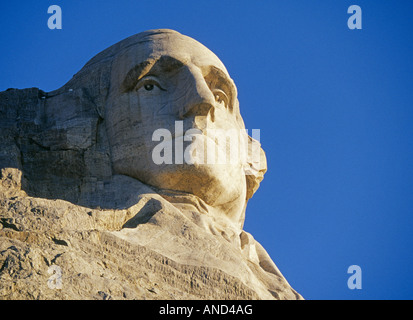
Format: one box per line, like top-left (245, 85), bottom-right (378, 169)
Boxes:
top-left (0, 169), bottom-right (301, 299)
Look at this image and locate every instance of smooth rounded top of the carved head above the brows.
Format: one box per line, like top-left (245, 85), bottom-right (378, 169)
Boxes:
top-left (62, 29), bottom-right (235, 96)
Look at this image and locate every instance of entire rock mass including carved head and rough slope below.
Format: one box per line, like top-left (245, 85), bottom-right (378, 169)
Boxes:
top-left (0, 30), bottom-right (302, 299)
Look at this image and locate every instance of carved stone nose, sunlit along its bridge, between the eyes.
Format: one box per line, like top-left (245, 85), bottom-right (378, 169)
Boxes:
top-left (179, 70), bottom-right (215, 119)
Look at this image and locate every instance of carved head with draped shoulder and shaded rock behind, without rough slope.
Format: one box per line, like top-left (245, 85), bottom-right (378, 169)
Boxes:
top-left (0, 29), bottom-right (301, 299)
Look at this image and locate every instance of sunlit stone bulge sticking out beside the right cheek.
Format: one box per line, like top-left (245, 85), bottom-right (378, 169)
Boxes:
top-left (244, 136), bottom-right (267, 200)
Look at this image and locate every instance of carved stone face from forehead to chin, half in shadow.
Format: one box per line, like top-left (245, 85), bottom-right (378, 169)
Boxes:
top-left (105, 31), bottom-right (246, 210)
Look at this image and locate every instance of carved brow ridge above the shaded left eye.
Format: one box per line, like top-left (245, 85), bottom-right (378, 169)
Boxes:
top-left (122, 56), bottom-right (184, 93)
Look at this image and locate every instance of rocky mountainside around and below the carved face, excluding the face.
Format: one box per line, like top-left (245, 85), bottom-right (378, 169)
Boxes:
top-left (0, 31), bottom-right (302, 299)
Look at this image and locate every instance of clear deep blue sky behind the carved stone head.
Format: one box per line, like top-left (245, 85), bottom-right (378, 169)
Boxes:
top-left (0, 0), bottom-right (413, 299)
